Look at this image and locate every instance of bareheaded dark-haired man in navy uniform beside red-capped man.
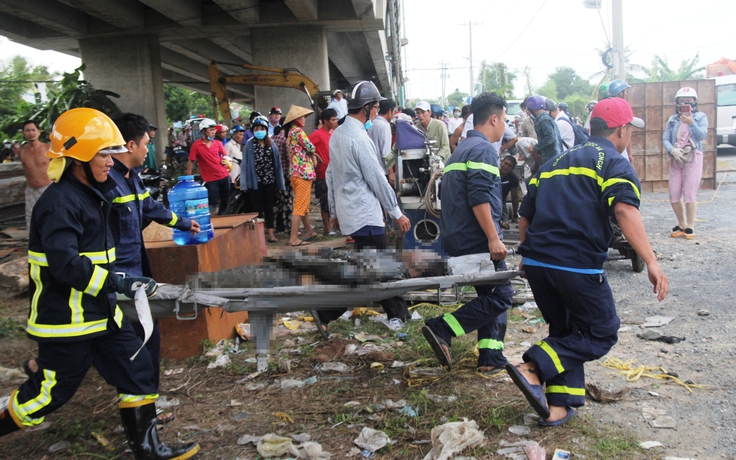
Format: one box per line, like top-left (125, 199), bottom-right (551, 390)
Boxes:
top-left (422, 93), bottom-right (514, 372)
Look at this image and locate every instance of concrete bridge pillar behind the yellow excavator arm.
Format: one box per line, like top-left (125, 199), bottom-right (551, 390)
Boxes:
top-left (251, 25), bottom-right (330, 132)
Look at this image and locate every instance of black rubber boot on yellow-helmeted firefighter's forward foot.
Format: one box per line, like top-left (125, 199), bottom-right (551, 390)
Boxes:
top-left (120, 403), bottom-right (199, 460)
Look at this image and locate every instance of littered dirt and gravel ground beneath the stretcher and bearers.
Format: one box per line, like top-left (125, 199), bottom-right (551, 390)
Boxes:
top-left (0, 156), bottom-right (736, 459)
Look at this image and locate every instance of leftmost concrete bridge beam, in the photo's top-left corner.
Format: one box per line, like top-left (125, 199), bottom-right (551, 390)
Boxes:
top-left (0, 0), bottom-right (87, 36)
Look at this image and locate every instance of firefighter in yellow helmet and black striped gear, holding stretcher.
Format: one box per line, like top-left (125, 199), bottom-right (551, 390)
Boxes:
top-left (0, 108), bottom-right (199, 459)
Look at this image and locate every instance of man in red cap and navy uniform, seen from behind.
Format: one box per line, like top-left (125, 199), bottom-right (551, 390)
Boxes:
top-left (506, 98), bottom-right (669, 426)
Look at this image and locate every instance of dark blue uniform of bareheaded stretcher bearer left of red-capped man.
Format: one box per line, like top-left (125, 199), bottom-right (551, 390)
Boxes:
top-left (426, 130), bottom-right (514, 367)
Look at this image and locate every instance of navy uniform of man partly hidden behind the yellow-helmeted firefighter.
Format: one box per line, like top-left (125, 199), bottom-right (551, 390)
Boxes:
top-left (104, 157), bottom-right (192, 388)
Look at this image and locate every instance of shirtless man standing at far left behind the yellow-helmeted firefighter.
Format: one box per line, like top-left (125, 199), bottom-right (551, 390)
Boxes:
top-left (20, 120), bottom-right (51, 229)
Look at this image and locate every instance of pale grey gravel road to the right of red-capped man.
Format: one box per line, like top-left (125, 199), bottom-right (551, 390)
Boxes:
top-left (585, 155), bottom-right (736, 459)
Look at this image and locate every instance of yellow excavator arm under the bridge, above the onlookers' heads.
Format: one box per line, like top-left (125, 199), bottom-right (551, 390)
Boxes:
top-left (208, 61), bottom-right (332, 122)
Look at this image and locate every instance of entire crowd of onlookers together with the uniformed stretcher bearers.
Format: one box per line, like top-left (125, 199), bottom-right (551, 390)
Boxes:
top-left (0, 74), bottom-right (708, 452)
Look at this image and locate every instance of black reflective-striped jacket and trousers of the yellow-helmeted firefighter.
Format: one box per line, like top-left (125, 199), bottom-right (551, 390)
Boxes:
top-left (9, 174), bottom-right (158, 426)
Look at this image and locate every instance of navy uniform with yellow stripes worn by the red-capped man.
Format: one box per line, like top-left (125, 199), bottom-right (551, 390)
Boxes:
top-left (519, 136), bottom-right (641, 407)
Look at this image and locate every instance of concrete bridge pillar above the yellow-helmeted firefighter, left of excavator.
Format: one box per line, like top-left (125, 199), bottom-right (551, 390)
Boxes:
top-left (79, 35), bottom-right (167, 166)
